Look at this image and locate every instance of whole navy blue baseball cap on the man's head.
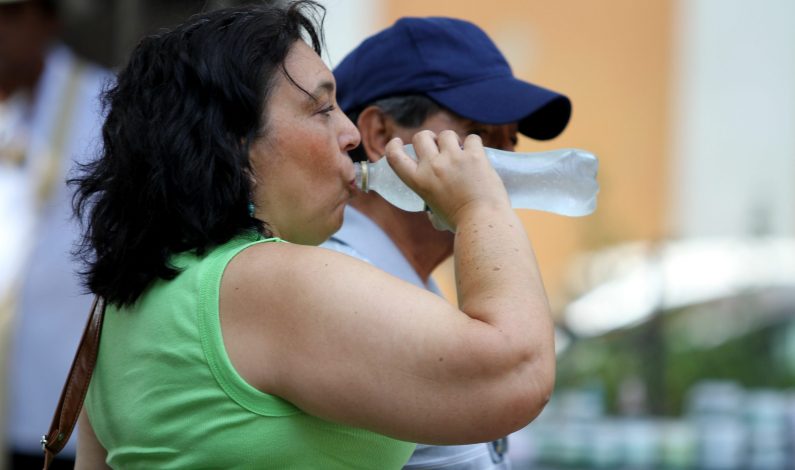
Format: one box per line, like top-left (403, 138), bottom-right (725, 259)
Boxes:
top-left (334, 17), bottom-right (571, 140)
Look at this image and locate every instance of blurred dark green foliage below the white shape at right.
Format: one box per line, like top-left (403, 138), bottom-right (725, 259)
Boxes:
top-left (557, 296), bottom-right (795, 416)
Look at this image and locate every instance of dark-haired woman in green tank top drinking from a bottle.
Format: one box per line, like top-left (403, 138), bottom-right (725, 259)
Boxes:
top-left (75, 2), bottom-right (554, 469)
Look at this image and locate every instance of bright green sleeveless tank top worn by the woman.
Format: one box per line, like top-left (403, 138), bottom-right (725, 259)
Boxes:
top-left (85, 234), bottom-right (414, 470)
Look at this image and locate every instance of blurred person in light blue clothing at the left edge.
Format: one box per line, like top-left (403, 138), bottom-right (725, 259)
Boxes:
top-left (0, 0), bottom-right (109, 468)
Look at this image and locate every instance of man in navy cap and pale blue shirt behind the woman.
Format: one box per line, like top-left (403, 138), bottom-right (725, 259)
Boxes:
top-left (322, 18), bottom-right (571, 469)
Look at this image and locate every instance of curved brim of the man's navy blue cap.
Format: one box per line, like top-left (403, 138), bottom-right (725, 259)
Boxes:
top-left (427, 77), bottom-right (571, 140)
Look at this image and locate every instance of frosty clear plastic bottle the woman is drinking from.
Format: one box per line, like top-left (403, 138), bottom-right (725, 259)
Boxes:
top-left (356, 144), bottom-right (599, 217)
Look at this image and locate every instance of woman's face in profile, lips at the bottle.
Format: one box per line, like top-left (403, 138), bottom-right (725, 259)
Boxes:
top-left (250, 41), bottom-right (359, 245)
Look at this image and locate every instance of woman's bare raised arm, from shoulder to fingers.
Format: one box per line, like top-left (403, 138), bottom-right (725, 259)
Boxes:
top-left (220, 134), bottom-right (554, 443)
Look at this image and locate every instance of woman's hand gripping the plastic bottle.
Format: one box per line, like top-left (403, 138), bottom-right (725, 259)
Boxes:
top-left (386, 130), bottom-right (510, 231)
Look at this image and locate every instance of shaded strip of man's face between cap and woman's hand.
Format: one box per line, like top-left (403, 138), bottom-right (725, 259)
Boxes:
top-left (393, 110), bottom-right (518, 151)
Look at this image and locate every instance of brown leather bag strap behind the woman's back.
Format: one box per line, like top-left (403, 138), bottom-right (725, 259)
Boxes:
top-left (41, 297), bottom-right (105, 470)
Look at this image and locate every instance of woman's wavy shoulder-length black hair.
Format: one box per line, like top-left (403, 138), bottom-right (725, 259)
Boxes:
top-left (69, 0), bottom-right (325, 306)
